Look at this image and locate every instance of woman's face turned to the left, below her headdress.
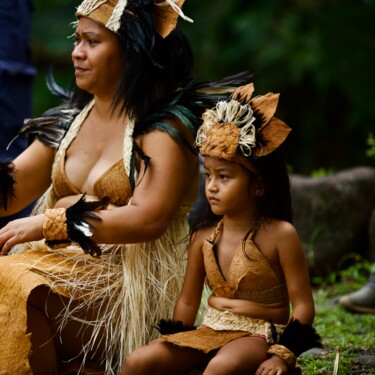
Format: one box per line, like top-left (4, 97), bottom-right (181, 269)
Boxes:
top-left (72, 17), bottom-right (124, 99)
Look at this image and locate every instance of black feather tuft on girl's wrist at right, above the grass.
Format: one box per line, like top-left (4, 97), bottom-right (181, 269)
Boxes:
top-left (278, 319), bottom-right (323, 357)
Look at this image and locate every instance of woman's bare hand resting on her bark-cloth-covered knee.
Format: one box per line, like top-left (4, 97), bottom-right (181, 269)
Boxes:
top-left (0, 214), bottom-right (45, 255)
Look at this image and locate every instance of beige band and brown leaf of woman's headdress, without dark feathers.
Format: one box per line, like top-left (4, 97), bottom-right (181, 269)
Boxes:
top-left (76, 0), bottom-right (193, 38)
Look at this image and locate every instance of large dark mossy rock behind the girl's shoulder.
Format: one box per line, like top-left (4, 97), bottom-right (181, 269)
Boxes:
top-left (291, 167), bottom-right (375, 275)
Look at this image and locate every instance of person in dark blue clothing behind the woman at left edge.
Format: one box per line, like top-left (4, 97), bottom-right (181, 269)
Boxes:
top-left (0, 0), bottom-right (36, 228)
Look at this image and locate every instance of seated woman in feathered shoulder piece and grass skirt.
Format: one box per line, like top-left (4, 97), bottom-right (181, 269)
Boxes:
top-left (0, 0), bottom-right (253, 374)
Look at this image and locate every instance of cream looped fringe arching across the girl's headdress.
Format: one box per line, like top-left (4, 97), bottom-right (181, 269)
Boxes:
top-left (195, 100), bottom-right (256, 156)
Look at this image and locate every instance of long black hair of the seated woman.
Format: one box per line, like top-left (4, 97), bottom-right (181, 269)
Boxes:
top-left (72, 28), bottom-right (193, 125)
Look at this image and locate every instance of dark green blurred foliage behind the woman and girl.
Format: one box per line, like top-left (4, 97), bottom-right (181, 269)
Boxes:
top-left (32, 0), bottom-right (375, 174)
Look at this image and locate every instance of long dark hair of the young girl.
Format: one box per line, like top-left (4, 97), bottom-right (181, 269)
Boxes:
top-left (190, 147), bottom-right (293, 233)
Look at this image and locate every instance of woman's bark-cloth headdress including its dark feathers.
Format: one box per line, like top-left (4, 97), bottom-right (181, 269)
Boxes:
top-left (76, 0), bottom-right (193, 65)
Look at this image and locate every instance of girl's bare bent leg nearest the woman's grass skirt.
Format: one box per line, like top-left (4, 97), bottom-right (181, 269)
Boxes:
top-left (121, 339), bottom-right (211, 375)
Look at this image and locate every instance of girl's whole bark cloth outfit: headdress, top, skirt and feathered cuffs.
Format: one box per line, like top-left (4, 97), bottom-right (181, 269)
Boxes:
top-left (157, 83), bottom-right (321, 374)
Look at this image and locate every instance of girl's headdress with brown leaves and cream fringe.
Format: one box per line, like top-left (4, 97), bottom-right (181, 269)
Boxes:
top-left (195, 83), bottom-right (291, 172)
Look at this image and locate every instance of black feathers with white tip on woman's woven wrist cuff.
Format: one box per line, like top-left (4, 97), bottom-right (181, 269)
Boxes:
top-left (66, 195), bottom-right (109, 257)
